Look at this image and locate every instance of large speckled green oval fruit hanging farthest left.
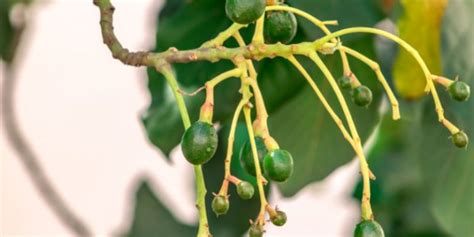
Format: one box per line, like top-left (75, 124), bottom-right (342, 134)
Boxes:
top-left (181, 121), bottom-right (217, 165)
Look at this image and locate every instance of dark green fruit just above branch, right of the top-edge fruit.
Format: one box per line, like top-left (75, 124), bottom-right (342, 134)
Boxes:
top-left (263, 11), bottom-right (298, 44)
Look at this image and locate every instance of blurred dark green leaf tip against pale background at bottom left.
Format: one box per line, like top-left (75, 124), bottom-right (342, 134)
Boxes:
top-left (126, 181), bottom-right (197, 237)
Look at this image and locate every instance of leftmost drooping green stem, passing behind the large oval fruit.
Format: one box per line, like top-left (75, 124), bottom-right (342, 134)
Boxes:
top-left (157, 64), bottom-right (212, 237)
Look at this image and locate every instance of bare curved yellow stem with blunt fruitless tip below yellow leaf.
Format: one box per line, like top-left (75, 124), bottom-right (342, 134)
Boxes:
top-left (341, 46), bottom-right (400, 120)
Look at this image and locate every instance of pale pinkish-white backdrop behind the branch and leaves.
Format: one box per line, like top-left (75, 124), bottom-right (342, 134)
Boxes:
top-left (0, 0), bottom-right (358, 237)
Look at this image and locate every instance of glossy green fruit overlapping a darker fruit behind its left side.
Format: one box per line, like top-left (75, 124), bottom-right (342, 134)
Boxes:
top-left (263, 149), bottom-right (293, 182)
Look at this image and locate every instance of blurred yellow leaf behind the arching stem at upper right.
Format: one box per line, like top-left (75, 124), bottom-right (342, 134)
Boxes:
top-left (393, 0), bottom-right (448, 100)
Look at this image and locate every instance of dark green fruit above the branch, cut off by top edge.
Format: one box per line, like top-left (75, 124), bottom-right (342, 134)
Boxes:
top-left (225, 0), bottom-right (266, 25)
